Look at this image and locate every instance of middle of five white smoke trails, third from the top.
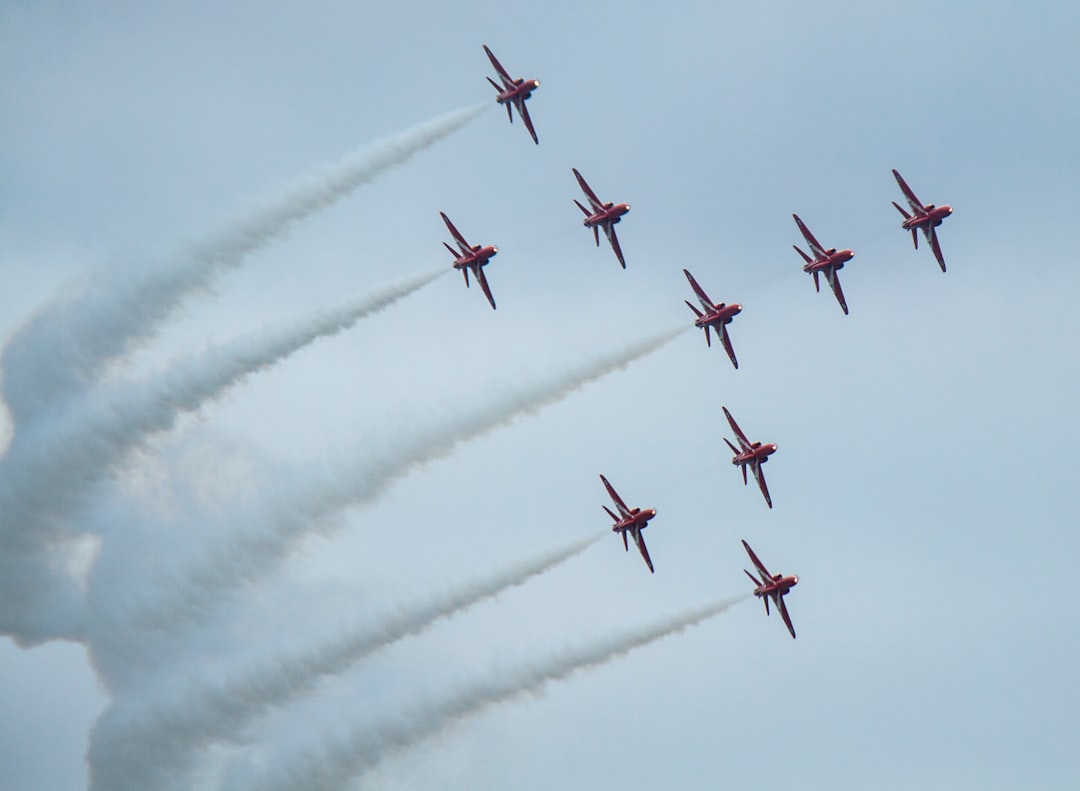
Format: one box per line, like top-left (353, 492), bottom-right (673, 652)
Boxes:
top-left (124, 325), bottom-right (692, 630)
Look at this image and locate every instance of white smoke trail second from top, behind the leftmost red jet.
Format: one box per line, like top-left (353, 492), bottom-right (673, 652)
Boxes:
top-left (0, 268), bottom-right (450, 640)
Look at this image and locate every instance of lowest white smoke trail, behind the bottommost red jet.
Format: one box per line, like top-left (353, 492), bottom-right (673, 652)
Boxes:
top-left (245, 594), bottom-right (750, 791)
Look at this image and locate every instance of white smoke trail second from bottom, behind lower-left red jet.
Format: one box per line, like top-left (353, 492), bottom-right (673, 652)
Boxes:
top-left (89, 531), bottom-right (608, 791)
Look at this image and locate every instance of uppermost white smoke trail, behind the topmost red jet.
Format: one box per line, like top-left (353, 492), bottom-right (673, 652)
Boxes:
top-left (0, 103), bottom-right (489, 429)
